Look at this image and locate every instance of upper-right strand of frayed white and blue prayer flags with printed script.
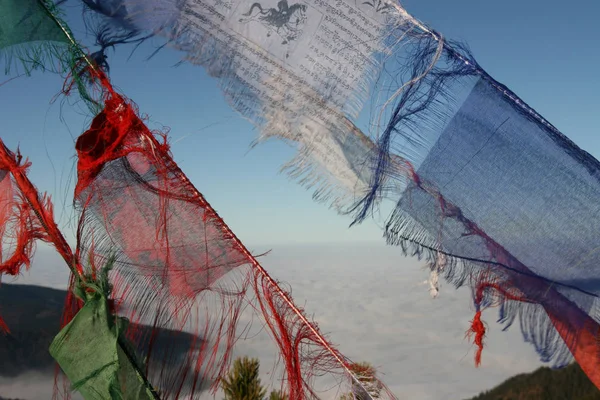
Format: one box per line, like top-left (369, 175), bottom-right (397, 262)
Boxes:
top-left (83, 0), bottom-right (600, 387)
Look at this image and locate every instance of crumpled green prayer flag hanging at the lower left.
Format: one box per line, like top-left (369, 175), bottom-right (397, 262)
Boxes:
top-left (50, 260), bottom-right (157, 400)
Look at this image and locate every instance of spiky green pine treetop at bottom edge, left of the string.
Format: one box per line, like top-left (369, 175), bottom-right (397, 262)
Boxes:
top-left (221, 357), bottom-right (267, 400)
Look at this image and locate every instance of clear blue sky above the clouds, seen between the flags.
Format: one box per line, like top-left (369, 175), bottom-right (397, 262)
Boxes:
top-left (0, 0), bottom-right (600, 247)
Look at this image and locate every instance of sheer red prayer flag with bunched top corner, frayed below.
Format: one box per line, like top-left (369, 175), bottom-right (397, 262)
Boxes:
top-left (69, 89), bottom-right (252, 399)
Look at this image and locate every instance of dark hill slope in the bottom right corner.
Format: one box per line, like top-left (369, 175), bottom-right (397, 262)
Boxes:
top-left (470, 364), bottom-right (600, 400)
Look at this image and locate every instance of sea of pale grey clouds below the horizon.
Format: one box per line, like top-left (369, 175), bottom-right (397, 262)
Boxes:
top-left (0, 244), bottom-right (541, 400)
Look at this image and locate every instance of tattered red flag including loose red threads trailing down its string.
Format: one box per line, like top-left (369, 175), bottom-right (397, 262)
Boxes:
top-left (69, 76), bottom-right (394, 400)
